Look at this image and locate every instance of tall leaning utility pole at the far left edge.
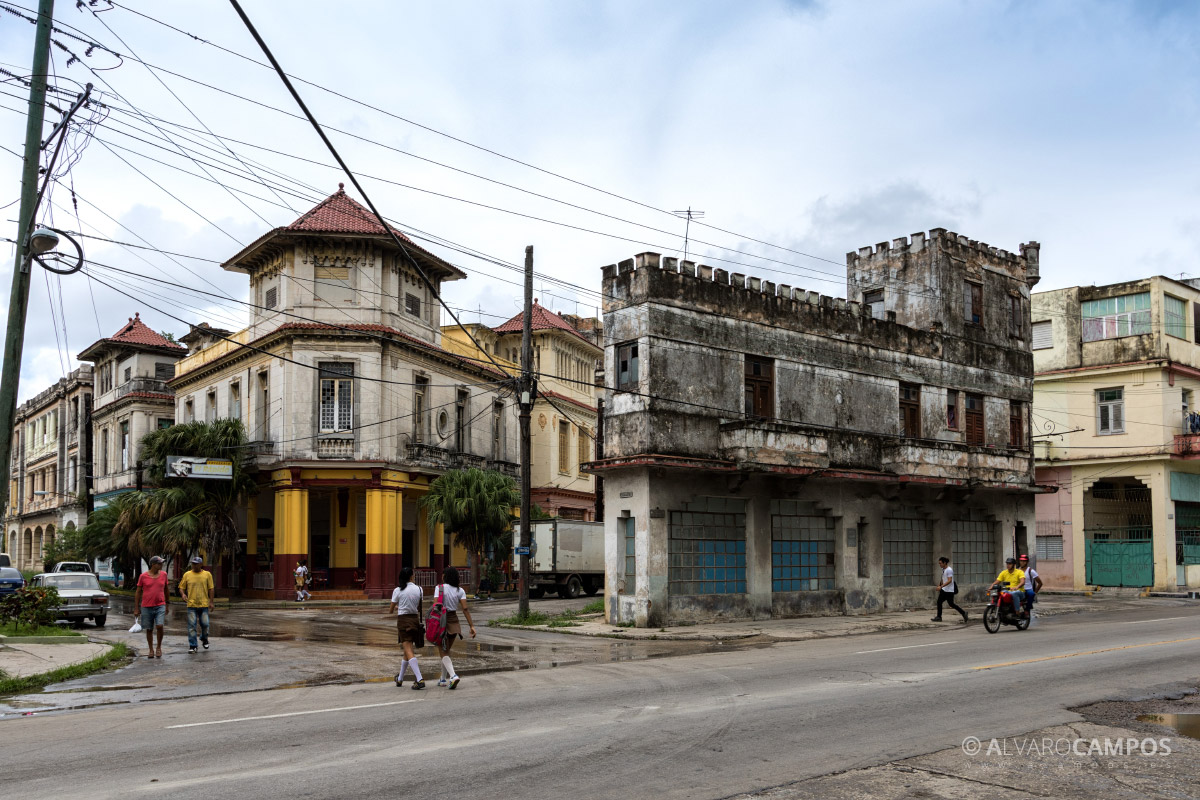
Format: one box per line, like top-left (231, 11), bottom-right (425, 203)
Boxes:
top-left (0, 0), bottom-right (54, 513)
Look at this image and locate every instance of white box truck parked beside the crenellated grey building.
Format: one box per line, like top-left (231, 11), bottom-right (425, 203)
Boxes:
top-left (512, 519), bottom-right (604, 600)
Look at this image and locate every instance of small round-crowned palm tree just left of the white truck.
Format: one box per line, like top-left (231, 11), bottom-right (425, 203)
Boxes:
top-left (421, 469), bottom-right (521, 591)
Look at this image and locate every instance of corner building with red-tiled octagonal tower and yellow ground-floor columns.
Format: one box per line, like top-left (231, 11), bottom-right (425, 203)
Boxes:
top-left (170, 188), bottom-right (518, 597)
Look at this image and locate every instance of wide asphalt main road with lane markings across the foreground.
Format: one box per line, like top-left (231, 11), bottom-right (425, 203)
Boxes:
top-left (0, 602), bottom-right (1200, 800)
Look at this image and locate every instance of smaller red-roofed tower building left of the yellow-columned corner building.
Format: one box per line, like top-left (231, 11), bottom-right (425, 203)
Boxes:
top-left (79, 314), bottom-right (187, 507)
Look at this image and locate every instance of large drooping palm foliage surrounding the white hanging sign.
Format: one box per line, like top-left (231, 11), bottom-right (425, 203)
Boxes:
top-left (139, 420), bottom-right (257, 561)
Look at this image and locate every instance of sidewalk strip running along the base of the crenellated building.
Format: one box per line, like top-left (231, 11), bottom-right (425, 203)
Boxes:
top-left (496, 596), bottom-right (1110, 642)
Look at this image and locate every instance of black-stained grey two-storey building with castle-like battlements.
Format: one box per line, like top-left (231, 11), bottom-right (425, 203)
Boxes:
top-left (592, 229), bottom-right (1038, 626)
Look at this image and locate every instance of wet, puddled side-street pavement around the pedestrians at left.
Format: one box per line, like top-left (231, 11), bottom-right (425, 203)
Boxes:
top-left (0, 596), bottom-right (748, 717)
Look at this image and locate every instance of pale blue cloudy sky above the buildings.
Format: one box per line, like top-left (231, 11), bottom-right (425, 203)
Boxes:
top-left (0, 0), bottom-right (1200, 399)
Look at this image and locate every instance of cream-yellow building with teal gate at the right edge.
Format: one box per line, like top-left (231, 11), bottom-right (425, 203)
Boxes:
top-left (1032, 276), bottom-right (1200, 591)
